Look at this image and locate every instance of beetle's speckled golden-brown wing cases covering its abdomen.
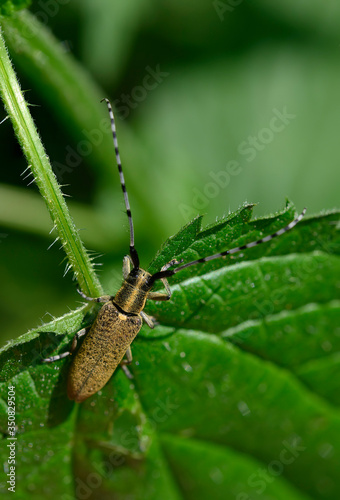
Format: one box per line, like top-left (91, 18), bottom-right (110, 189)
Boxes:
top-left (67, 302), bottom-right (142, 403)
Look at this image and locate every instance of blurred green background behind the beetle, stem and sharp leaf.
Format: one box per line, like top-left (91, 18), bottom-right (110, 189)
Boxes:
top-left (0, 0), bottom-right (340, 344)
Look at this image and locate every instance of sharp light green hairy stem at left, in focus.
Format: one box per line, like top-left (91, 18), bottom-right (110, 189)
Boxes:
top-left (0, 27), bottom-right (102, 297)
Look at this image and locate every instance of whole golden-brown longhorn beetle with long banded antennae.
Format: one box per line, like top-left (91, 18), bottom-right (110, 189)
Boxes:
top-left (43, 99), bottom-right (306, 403)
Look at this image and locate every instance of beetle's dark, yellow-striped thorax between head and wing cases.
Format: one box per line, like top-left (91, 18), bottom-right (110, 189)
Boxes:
top-left (113, 269), bottom-right (152, 314)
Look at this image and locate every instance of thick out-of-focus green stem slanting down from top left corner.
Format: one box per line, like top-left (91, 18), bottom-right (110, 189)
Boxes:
top-left (0, 10), bottom-right (117, 185)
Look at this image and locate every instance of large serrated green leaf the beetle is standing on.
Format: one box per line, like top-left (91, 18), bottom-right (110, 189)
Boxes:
top-left (0, 203), bottom-right (340, 500)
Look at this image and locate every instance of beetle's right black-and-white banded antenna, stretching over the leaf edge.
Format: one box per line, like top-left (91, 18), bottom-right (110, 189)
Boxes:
top-left (151, 208), bottom-right (306, 281)
